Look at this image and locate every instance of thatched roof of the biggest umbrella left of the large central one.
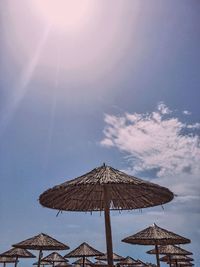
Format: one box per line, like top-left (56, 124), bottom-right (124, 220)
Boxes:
top-left (13, 233), bottom-right (69, 250)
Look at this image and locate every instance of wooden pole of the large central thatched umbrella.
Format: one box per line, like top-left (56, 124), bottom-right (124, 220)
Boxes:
top-left (104, 187), bottom-right (113, 267)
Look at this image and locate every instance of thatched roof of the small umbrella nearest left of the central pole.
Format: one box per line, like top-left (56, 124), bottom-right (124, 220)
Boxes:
top-left (64, 242), bottom-right (103, 258)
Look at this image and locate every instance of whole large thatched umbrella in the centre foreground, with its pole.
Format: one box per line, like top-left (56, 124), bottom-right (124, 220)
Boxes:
top-left (39, 164), bottom-right (174, 266)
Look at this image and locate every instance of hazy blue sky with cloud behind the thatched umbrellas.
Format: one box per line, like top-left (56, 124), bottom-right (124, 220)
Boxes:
top-left (0, 0), bottom-right (200, 266)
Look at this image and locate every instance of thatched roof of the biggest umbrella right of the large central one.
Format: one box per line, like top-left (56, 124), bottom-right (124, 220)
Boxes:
top-left (122, 224), bottom-right (190, 245)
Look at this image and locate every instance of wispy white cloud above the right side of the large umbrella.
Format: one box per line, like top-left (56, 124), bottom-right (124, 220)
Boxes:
top-left (101, 102), bottom-right (200, 203)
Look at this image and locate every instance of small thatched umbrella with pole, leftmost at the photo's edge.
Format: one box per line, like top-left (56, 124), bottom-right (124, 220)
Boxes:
top-left (0, 248), bottom-right (35, 267)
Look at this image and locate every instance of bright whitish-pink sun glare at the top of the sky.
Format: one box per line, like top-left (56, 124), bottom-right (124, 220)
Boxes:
top-left (33, 0), bottom-right (94, 31)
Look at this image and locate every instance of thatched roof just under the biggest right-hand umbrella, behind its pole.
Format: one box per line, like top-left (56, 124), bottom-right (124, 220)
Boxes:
top-left (147, 245), bottom-right (192, 255)
